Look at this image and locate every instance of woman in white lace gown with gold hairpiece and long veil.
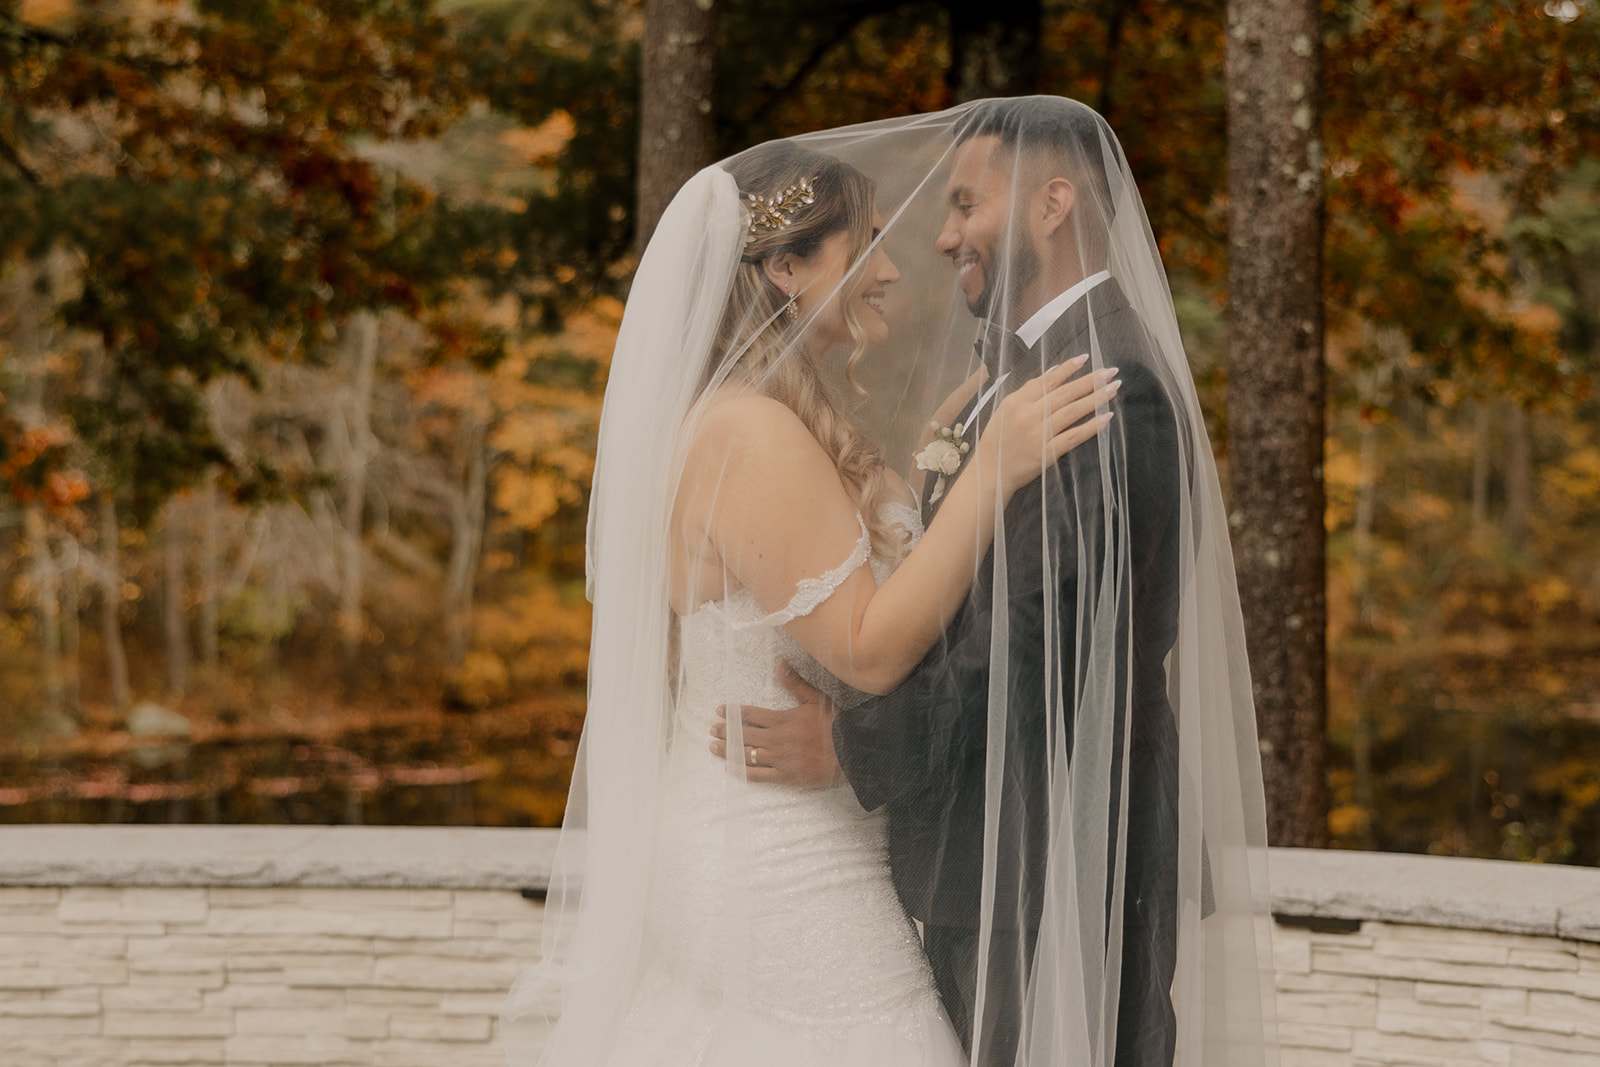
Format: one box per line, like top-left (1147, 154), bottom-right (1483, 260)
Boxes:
top-left (502, 99), bottom-right (1261, 1067)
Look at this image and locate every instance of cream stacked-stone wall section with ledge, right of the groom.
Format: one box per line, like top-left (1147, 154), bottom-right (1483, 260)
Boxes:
top-left (1269, 849), bottom-right (1600, 1067)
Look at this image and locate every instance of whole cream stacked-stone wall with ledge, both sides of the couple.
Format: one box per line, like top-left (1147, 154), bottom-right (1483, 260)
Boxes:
top-left (0, 827), bottom-right (1600, 1067)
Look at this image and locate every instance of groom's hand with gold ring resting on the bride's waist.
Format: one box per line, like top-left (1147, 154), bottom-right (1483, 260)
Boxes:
top-left (710, 662), bottom-right (843, 789)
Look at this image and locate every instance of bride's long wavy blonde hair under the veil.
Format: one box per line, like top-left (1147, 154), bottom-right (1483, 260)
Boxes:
top-left (702, 141), bottom-right (906, 558)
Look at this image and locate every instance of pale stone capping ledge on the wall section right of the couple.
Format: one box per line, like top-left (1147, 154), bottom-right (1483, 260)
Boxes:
top-left (1267, 848), bottom-right (1600, 942)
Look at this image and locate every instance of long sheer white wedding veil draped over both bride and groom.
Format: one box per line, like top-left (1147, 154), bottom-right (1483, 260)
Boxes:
top-left (502, 98), bottom-right (1275, 1067)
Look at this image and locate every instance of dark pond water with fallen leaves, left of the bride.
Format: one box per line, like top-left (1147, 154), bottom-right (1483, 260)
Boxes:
top-left (0, 701), bottom-right (582, 825)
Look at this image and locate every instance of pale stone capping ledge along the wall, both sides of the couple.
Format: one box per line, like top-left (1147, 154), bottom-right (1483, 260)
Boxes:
top-left (0, 825), bottom-right (1600, 942)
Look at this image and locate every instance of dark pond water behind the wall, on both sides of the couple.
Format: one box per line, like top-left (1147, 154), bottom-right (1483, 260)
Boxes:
top-left (12, 656), bottom-right (1600, 865)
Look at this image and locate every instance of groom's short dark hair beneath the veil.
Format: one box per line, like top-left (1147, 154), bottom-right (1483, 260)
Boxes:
top-left (955, 96), bottom-right (1125, 229)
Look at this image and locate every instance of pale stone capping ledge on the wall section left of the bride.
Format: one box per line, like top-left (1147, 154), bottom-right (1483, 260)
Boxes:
top-left (0, 825), bottom-right (557, 889)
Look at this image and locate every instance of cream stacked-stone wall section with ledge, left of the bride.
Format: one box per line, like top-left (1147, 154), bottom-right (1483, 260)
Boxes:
top-left (0, 827), bottom-right (552, 1067)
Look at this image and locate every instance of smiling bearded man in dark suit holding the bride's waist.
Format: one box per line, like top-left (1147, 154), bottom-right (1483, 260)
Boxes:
top-left (712, 98), bottom-right (1182, 1067)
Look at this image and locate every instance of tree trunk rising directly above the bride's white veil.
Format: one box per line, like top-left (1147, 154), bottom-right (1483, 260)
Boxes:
top-left (634, 0), bottom-right (717, 253)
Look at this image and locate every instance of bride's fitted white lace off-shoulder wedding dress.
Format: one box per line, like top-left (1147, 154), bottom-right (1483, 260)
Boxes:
top-left (610, 504), bottom-right (966, 1067)
